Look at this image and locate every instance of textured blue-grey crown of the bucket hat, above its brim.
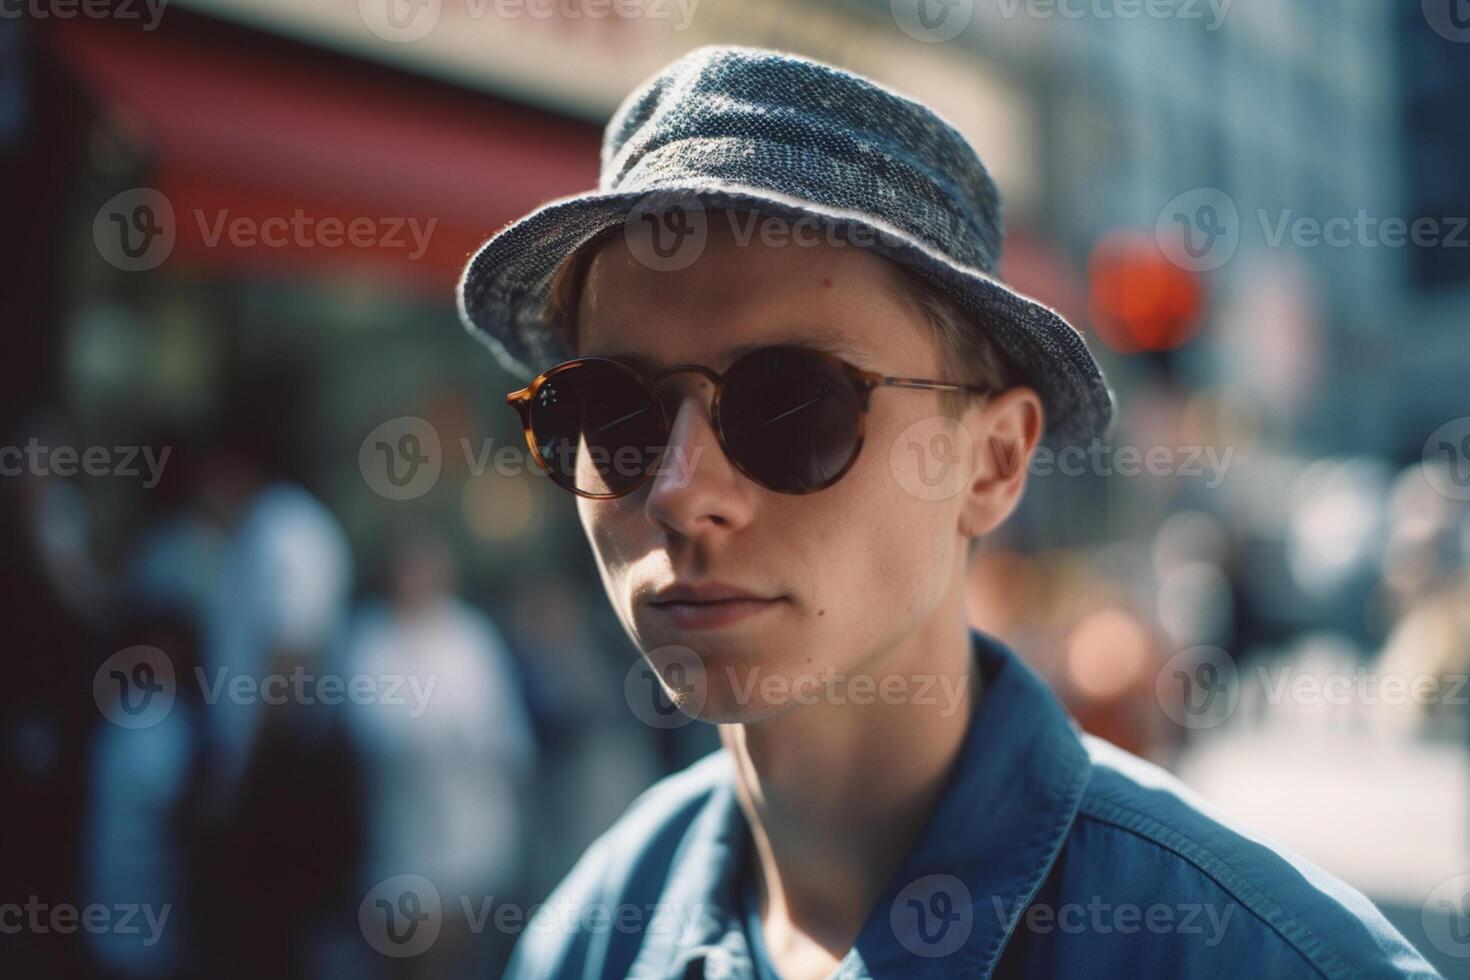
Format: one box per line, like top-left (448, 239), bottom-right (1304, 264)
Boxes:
top-left (598, 44), bottom-right (1003, 273)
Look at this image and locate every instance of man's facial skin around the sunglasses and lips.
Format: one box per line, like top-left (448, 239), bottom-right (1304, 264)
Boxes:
top-left (576, 212), bottom-right (969, 723)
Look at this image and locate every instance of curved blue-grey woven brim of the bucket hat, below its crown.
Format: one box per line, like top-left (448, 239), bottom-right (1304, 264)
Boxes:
top-left (456, 184), bottom-right (1113, 450)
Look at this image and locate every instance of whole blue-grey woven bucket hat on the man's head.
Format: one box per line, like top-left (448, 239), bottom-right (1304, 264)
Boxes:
top-left (456, 44), bottom-right (1113, 448)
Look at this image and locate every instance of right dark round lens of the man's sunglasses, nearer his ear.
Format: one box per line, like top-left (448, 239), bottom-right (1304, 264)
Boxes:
top-left (720, 350), bottom-right (861, 494)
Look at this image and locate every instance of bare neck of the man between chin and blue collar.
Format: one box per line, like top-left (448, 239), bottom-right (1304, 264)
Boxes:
top-left (720, 597), bottom-right (979, 958)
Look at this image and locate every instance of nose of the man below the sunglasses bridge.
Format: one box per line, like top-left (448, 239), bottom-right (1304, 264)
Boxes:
top-left (644, 373), bottom-right (754, 536)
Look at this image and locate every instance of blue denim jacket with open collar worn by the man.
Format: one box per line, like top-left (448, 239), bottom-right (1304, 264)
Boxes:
top-left (507, 630), bottom-right (1439, 980)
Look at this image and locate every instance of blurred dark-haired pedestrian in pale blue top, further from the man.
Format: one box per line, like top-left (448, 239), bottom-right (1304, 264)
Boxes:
top-left (186, 370), bottom-right (353, 977)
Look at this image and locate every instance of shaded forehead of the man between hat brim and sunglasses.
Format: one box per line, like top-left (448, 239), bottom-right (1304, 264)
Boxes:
top-left (576, 212), bottom-right (933, 370)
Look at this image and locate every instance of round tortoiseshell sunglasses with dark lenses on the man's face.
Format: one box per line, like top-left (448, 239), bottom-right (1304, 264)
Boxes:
top-left (506, 344), bottom-right (988, 500)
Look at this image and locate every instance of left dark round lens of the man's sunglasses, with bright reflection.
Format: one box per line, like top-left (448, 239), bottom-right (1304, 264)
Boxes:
top-left (531, 361), bottom-right (663, 495)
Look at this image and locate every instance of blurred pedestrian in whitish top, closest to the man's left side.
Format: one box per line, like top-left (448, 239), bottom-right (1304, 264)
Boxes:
top-left (344, 525), bottom-right (535, 977)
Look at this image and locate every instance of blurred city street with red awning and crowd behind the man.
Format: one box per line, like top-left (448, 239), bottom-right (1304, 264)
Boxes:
top-left (0, 0), bottom-right (1470, 979)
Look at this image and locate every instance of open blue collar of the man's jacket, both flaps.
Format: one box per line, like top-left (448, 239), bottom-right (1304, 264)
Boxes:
top-left (631, 629), bottom-right (1091, 979)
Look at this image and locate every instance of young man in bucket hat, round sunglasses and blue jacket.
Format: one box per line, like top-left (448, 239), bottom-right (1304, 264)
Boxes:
top-left (459, 47), bottom-right (1433, 979)
